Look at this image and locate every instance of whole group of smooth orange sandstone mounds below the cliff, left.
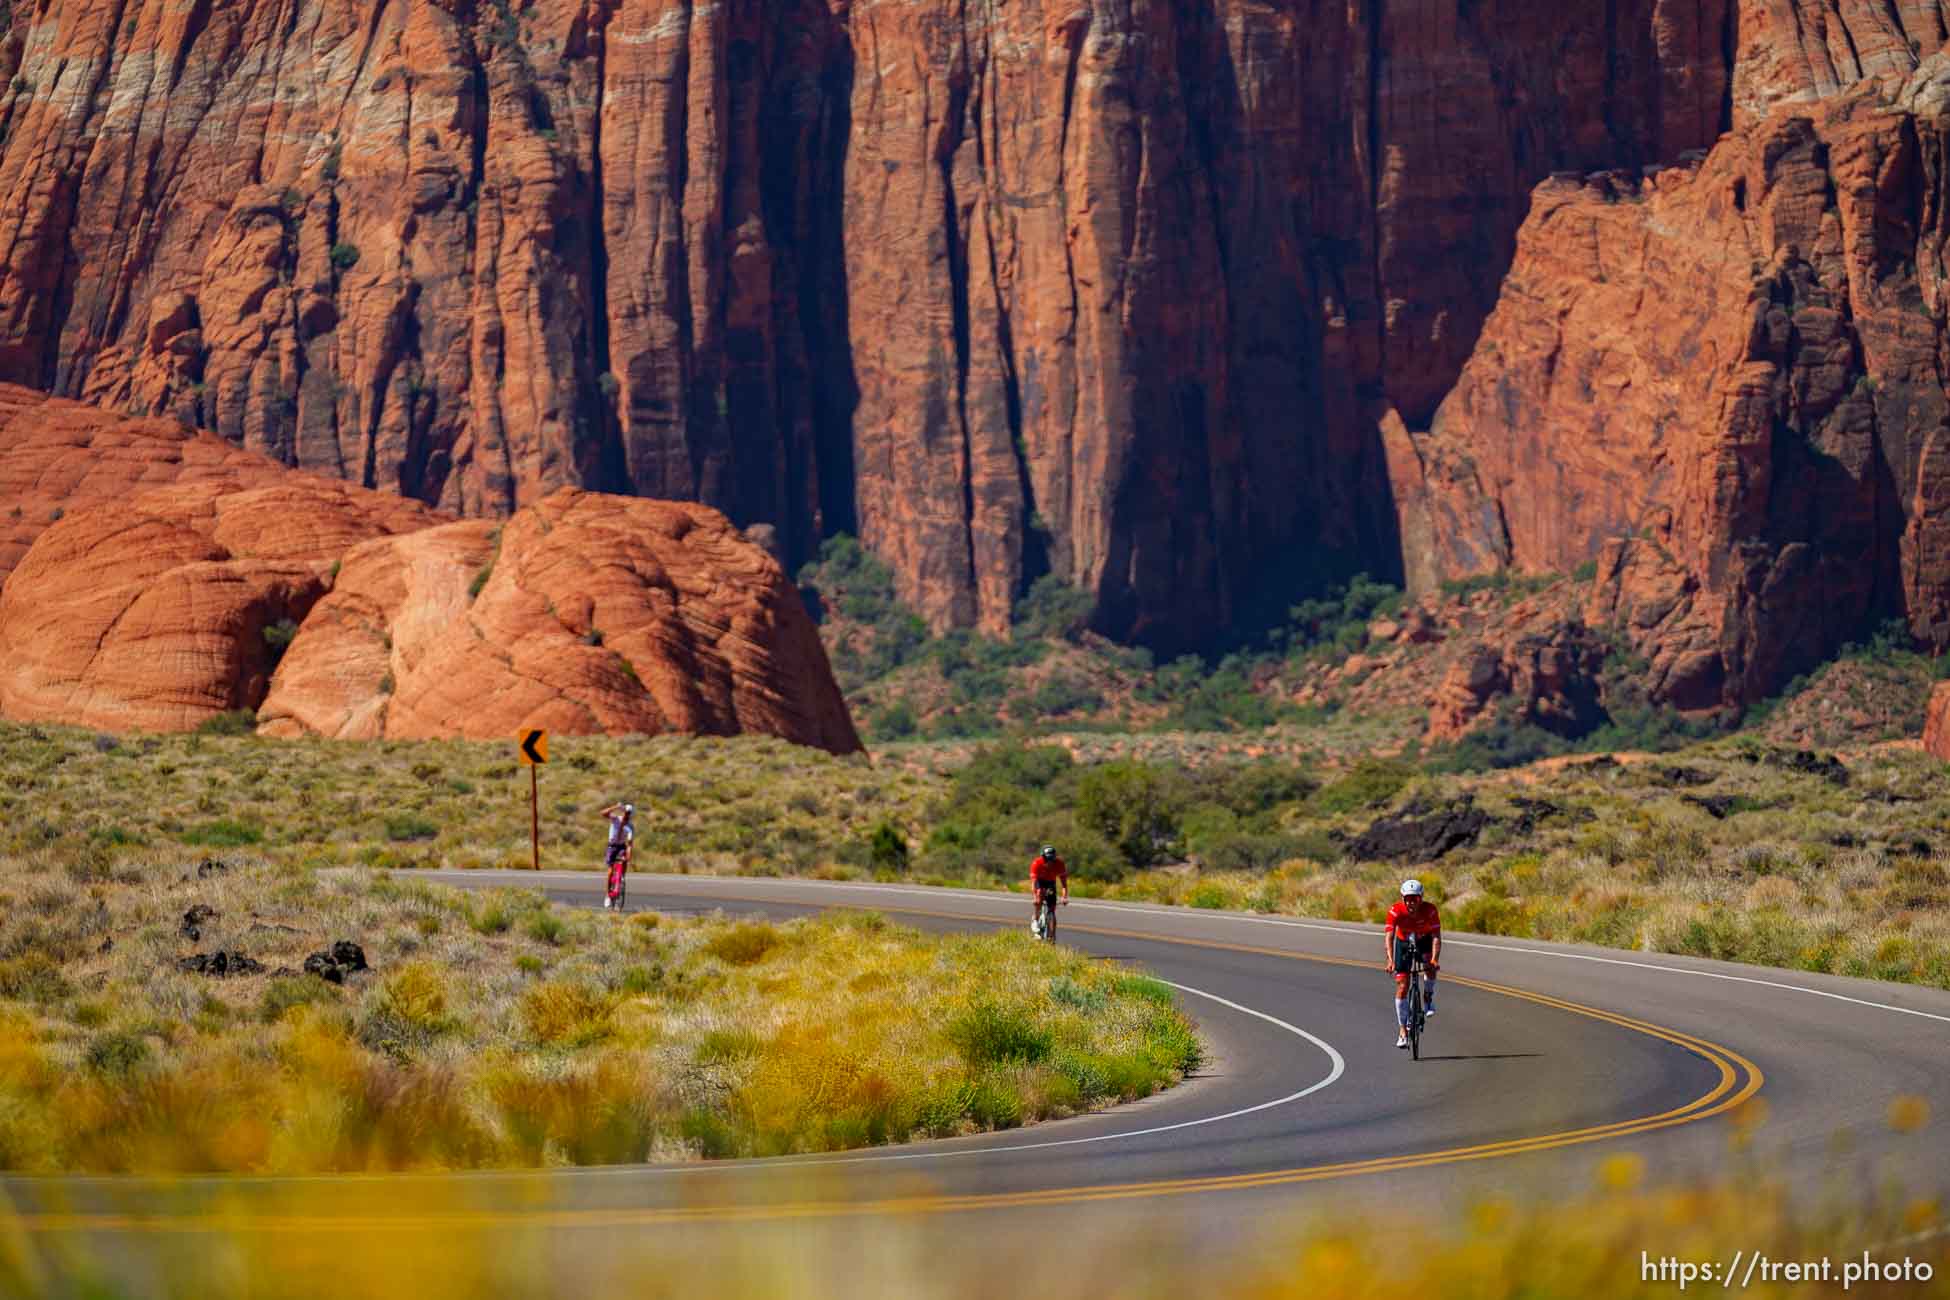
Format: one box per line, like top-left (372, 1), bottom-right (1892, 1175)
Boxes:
top-left (0, 397), bottom-right (860, 752)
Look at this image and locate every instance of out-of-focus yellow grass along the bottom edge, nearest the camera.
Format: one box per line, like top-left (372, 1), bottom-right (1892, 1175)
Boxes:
top-left (0, 1156), bottom-right (1950, 1300)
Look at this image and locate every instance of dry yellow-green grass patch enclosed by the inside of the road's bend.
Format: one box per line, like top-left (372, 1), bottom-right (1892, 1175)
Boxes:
top-left (0, 854), bottom-right (1199, 1171)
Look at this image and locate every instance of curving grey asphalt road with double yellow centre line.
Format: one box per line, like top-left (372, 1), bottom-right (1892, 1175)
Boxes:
top-left (4, 871), bottom-right (1950, 1286)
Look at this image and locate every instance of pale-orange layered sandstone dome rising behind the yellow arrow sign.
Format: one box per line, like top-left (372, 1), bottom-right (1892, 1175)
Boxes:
top-left (259, 489), bottom-right (860, 752)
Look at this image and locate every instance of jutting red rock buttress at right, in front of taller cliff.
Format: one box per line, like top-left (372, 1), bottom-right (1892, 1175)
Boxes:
top-left (1402, 71), bottom-right (1950, 709)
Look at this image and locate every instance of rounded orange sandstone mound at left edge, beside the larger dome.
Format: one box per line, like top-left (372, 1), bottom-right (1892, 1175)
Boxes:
top-left (0, 472), bottom-right (439, 731)
